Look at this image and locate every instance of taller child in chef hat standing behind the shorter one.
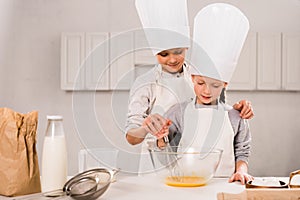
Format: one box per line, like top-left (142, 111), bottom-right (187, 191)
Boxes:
top-left (125, 0), bottom-right (253, 172)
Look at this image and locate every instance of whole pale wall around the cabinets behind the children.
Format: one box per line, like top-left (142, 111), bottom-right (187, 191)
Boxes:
top-left (0, 0), bottom-right (300, 176)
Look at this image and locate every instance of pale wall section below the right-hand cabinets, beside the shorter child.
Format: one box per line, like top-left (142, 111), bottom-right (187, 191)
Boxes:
top-left (227, 91), bottom-right (300, 176)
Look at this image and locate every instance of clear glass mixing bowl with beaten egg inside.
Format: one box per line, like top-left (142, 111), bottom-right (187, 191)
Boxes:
top-left (149, 146), bottom-right (222, 187)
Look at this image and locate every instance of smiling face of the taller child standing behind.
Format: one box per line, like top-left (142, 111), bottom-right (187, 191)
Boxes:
top-left (156, 48), bottom-right (186, 73)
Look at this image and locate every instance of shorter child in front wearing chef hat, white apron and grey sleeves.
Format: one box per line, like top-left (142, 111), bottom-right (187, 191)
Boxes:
top-left (158, 3), bottom-right (253, 184)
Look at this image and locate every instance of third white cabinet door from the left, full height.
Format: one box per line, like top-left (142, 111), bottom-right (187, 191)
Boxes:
top-left (110, 32), bottom-right (134, 90)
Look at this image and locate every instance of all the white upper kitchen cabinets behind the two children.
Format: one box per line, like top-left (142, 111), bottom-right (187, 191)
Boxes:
top-left (61, 30), bottom-right (300, 91)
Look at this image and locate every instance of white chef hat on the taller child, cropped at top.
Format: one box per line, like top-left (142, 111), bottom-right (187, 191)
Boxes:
top-left (135, 0), bottom-right (190, 55)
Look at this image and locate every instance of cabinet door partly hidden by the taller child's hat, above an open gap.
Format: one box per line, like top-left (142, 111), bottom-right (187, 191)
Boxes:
top-left (134, 30), bottom-right (157, 65)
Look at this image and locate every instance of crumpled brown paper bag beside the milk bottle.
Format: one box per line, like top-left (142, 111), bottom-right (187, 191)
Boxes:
top-left (0, 108), bottom-right (41, 196)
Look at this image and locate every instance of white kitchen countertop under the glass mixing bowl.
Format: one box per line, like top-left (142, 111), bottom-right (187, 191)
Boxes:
top-left (0, 174), bottom-right (245, 200)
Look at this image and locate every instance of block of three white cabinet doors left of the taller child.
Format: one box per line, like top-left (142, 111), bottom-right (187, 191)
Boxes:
top-left (61, 32), bottom-right (134, 90)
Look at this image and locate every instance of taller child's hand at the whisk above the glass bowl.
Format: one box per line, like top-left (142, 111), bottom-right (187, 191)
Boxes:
top-left (142, 114), bottom-right (172, 139)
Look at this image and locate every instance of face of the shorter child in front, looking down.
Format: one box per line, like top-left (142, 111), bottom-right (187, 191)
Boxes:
top-left (192, 75), bottom-right (227, 105)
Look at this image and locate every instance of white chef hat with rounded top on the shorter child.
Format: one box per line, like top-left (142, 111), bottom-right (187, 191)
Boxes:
top-left (190, 3), bottom-right (249, 82)
